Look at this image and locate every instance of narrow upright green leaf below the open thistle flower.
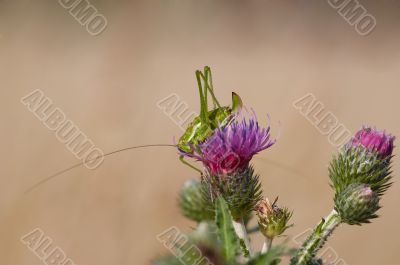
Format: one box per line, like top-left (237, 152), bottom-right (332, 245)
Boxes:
top-left (215, 197), bottom-right (240, 262)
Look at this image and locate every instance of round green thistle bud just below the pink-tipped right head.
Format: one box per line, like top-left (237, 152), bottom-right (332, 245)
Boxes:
top-left (335, 183), bottom-right (380, 225)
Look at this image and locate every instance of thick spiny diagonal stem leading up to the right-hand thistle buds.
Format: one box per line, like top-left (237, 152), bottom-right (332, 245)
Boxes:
top-left (290, 210), bottom-right (341, 265)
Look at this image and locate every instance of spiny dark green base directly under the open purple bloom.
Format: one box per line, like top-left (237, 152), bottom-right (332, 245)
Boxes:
top-left (201, 166), bottom-right (262, 220)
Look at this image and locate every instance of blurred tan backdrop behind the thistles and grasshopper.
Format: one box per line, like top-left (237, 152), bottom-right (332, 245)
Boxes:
top-left (0, 0), bottom-right (400, 265)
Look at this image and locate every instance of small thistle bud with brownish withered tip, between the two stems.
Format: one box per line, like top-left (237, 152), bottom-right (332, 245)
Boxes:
top-left (255, 198), bottom-right (292, 238)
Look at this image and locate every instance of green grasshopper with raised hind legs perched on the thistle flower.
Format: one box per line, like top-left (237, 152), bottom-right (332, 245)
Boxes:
top-left (177, 66), bottom-right (243, 173)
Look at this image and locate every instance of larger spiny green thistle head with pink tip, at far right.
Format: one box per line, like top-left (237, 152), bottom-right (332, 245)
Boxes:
top-left (329, 127), bottom-right (395, 196)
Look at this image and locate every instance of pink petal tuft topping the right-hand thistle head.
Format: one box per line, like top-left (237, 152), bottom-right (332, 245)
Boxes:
top-left (350, 127), bottom-right (395, 158)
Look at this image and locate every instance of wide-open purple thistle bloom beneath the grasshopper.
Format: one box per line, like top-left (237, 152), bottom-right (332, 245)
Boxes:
top-left (183, 112), bottom-right (276, 175)
